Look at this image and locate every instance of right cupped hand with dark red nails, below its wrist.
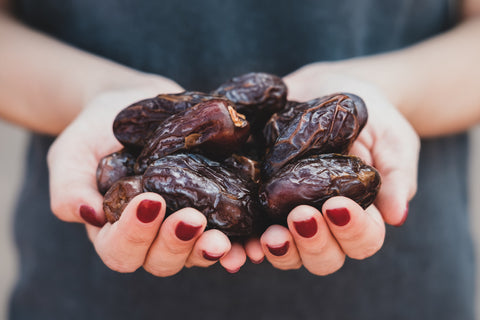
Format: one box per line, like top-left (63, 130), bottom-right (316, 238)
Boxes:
top-left (245, 64), bottom-right (419, 275)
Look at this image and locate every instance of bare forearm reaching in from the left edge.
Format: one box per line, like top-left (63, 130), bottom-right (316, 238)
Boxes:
top-left (0, 11), bottom-right (171, 134)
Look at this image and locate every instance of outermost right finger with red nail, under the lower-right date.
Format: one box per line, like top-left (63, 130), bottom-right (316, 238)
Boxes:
top-left (322, 197), bottom-right (385, 259)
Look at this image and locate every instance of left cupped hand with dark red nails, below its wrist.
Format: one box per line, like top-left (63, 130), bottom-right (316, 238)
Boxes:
top-left (48, 80), bottom-right (246, 276)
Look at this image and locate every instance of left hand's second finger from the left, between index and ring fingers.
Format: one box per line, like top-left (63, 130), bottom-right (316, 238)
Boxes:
top-left (143, 208), bottom-right (207, 277)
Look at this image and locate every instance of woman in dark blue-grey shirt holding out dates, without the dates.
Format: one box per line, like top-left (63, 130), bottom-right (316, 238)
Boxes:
top-left (0, 0), bottom-right (480, 319)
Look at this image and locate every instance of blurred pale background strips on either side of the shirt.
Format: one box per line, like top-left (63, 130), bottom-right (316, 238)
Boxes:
top-left (0, 120), bottom-right (480, 320)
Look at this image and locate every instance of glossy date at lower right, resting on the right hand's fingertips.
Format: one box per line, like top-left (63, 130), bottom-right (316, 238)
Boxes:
top-left (259, 154), bottom-right (381, 223)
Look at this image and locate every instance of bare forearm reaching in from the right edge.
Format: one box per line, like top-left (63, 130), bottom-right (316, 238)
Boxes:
top-left (334, 18), bottom-right (480, 136)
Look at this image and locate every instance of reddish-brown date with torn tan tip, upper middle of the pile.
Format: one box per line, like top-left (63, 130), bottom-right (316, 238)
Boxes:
top-left (135, 99), bottom-right (250, 174)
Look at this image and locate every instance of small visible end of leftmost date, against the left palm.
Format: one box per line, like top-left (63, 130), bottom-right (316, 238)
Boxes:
top-left (96, 149), bottom-right (136, 194)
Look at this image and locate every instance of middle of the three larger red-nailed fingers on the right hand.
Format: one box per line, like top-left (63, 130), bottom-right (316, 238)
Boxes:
top-left (287, 206), bottom-right (345, 276)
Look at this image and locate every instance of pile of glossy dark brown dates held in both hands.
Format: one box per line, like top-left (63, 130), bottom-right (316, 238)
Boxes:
top-left (97, 73), bottom-right (380, 237)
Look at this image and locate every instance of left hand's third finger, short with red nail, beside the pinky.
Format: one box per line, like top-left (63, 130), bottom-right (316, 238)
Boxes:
top-left (185, 229), bottom-right (232, 268)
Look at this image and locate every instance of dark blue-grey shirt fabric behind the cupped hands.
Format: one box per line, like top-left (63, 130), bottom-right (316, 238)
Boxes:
top-left (9, 0), bottom-right (475, 320)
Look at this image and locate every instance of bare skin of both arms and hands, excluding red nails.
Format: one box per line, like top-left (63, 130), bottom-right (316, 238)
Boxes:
top-left (0, 0), bottom-right (480, 277)
